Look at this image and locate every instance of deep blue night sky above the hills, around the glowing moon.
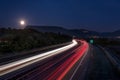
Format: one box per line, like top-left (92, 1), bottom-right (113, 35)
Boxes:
top-left (0, 0), bottom-right (120, 32)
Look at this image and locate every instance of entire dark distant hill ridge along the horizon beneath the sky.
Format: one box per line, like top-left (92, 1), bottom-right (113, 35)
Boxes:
top-left (26, 26), bottom-right (120, 38)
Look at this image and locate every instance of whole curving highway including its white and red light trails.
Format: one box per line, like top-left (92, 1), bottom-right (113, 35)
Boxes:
top-left (0, 39), bottom-right (120, 80)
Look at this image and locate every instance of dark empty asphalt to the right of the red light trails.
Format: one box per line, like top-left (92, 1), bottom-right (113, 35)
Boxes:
top-left (63, 45), bottom-right (120, 80)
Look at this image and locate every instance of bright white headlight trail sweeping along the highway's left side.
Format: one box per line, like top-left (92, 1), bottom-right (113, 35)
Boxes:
top-left (0, 40), bottom-right (78, 76)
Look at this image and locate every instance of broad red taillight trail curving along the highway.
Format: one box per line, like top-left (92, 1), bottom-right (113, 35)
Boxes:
top-left (48, 41), bottom-right (88, 80)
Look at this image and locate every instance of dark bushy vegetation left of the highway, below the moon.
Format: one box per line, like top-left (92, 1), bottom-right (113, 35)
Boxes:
top-left (0, 28), bottom-right (72, 53)
